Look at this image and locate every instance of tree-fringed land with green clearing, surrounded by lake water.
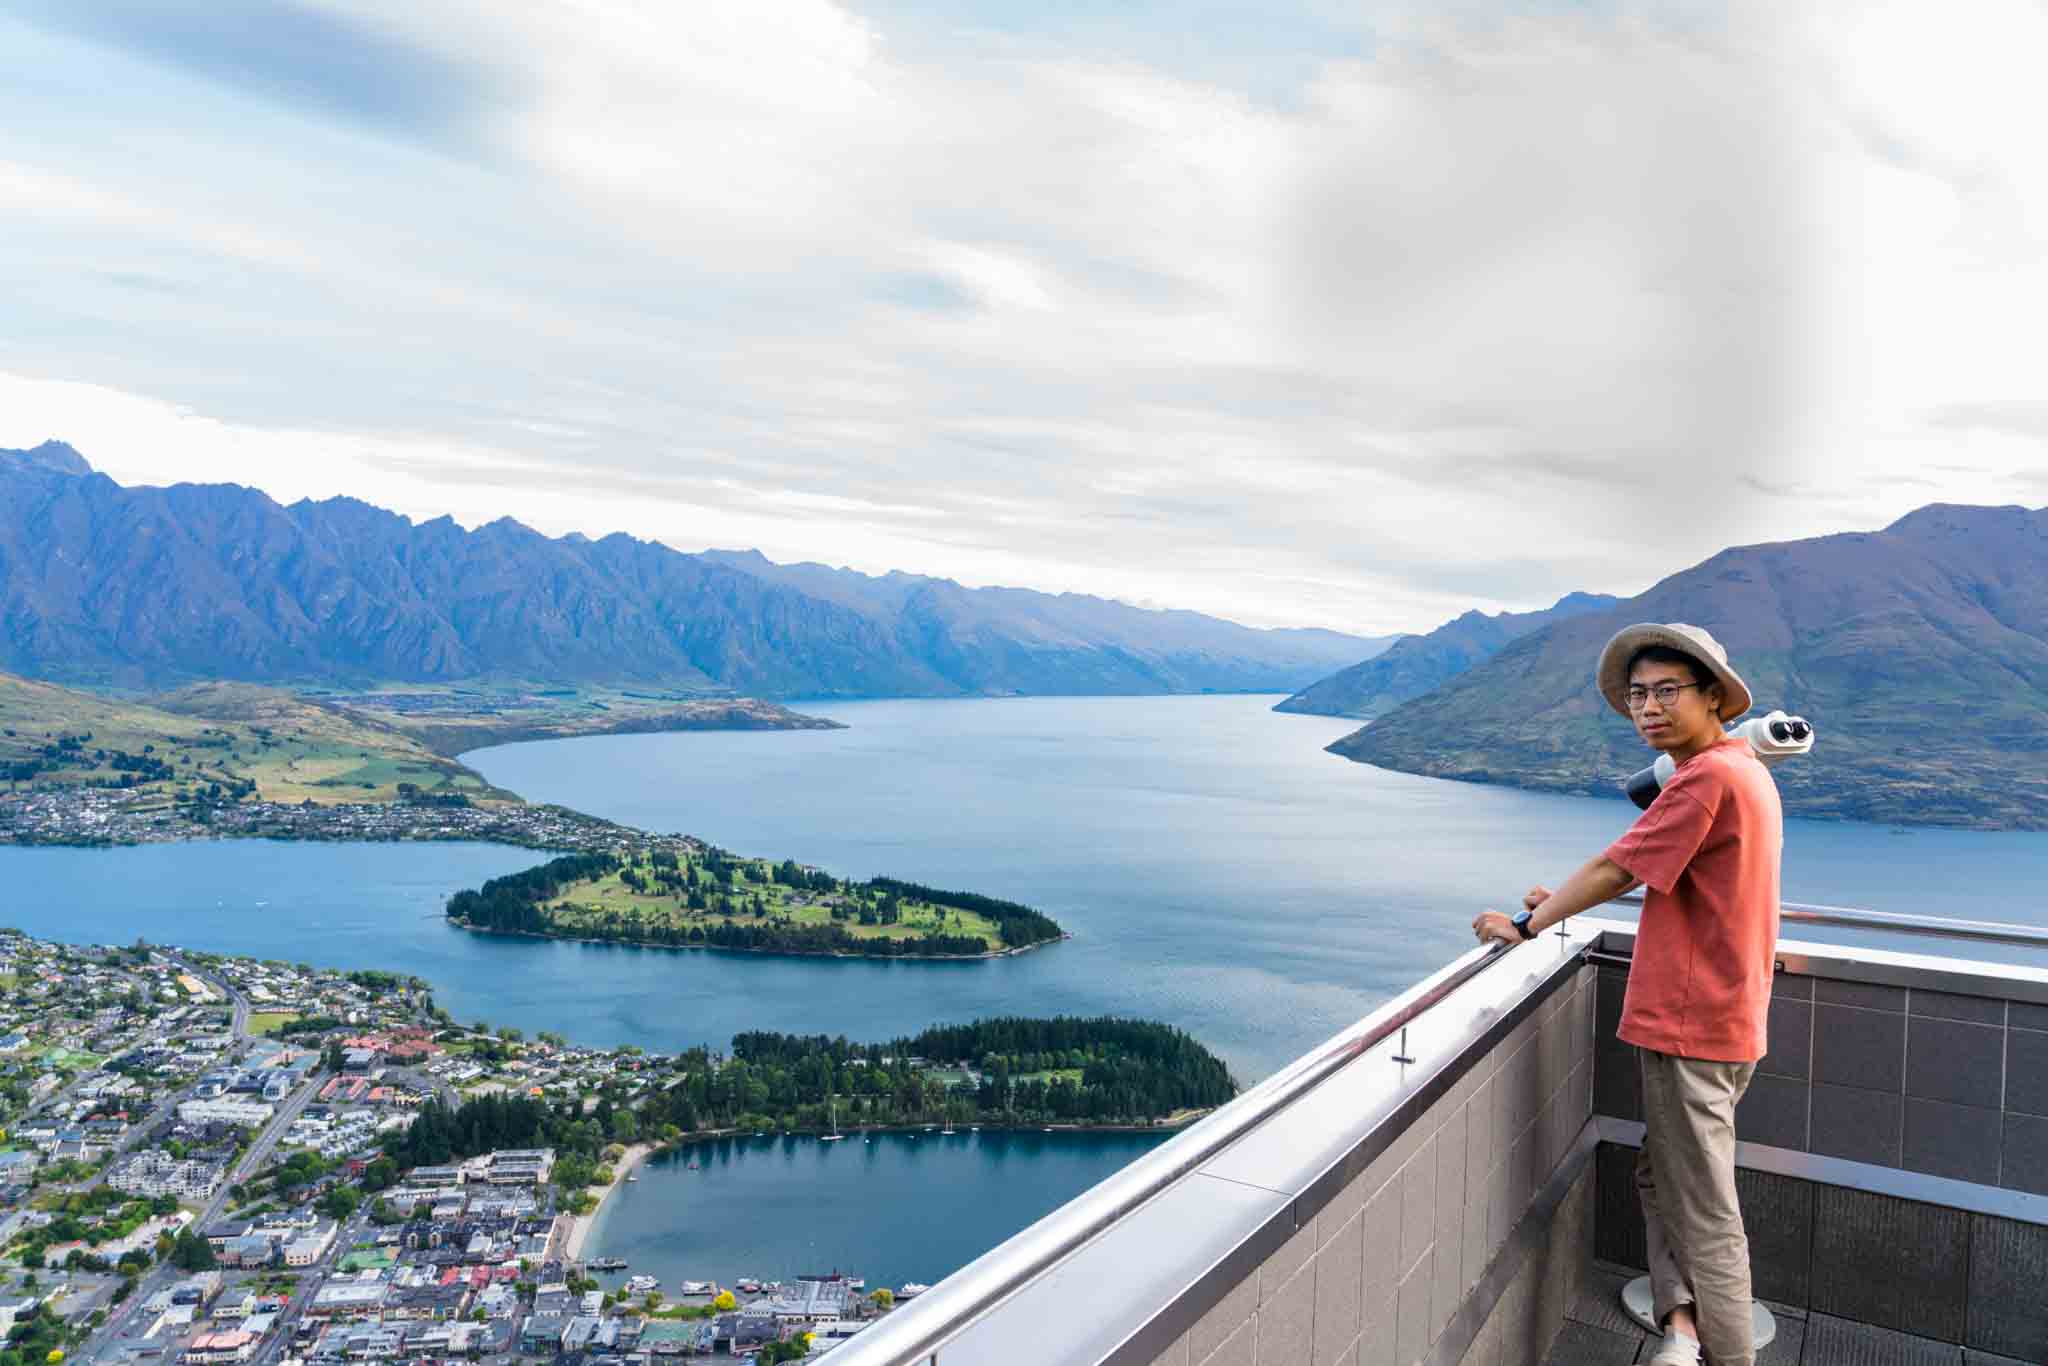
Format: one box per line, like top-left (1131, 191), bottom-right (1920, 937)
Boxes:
top-left (446, 842), bottom-right (1065, 958)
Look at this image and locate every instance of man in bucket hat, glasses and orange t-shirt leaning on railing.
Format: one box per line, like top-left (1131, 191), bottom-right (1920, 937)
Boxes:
top-left (1473, 623), bottom-right (1784, 1366)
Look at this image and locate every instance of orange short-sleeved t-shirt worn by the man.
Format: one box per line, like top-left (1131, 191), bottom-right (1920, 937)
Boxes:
top-left (1608, 737), bottom-right (1784, 1063)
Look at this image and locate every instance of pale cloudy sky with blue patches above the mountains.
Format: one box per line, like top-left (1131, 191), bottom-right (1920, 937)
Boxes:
top-left (0, 0), bottom-right (2048, 631)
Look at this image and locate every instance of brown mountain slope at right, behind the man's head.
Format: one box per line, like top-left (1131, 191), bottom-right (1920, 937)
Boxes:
top-left (1329, 504), bottom-right (2048, 829)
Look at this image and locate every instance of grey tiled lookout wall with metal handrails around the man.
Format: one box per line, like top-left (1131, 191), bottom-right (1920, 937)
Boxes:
top-left (831, 905), bottom-right (2048, 1366)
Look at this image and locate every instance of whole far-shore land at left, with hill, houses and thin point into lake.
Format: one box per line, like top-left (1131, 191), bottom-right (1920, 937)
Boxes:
top-left (0, 674), bottom-right (840, 850)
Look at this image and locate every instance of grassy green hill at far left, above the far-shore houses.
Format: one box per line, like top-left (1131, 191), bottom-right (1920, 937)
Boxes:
top-left (0, 674), bottom-right (518, 805)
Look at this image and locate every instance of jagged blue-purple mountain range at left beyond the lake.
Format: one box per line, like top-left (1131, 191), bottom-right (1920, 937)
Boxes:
top-left (0, 442), bottom-right (1378, 698)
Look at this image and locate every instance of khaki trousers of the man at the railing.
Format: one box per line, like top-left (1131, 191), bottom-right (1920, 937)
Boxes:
top-left (1636, 1049), bottom-right (1757, 1366)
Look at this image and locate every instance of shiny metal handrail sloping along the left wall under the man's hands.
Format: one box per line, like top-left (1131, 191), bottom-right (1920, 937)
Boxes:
top-left (831, 944), bottom-right (1509, 1366)
